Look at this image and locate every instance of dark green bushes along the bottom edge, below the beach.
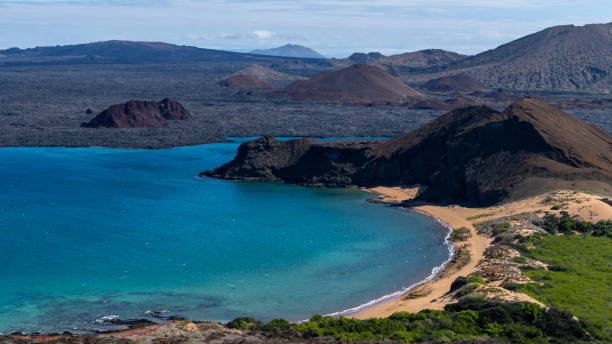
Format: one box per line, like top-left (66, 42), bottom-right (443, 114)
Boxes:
top-left (228, 297), bottom-right (590, 343)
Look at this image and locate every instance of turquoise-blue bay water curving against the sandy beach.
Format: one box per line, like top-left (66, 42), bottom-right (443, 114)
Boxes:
top-left (0, 139), bottom-right (448, 332)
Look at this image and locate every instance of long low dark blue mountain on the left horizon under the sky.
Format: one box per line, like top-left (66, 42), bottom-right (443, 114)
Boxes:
top-left (0, 41), bottom-right (322, 65)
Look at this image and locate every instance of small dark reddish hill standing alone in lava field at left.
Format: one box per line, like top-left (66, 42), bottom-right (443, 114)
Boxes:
top-left (81, 98), bottom-right (191, 128)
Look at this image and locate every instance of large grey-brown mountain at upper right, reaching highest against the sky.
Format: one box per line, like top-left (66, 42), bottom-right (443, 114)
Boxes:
top-left (436, 23), bottom-right (612, 92)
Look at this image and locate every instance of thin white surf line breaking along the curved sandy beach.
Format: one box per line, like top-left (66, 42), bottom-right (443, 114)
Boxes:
top-left (320, 209), bottom-right (455, 322)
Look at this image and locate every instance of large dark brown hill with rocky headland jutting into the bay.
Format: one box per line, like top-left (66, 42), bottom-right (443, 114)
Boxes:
top-left (205, 98), bottom-right (612, 204)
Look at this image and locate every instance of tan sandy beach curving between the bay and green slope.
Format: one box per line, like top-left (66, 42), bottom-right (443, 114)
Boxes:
top-left (349, 187), bottom-right (612, 319)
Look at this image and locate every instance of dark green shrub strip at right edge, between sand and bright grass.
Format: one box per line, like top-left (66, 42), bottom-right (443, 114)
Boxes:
top-left (534, 211), bottom-right (612, 238)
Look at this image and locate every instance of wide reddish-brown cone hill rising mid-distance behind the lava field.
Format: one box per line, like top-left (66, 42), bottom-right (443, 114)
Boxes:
top-left (269, 65), bottom-right (421, 103)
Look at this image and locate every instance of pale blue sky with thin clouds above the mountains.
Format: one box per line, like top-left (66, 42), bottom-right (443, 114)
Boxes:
top-left (0, 0), bottom-right (612, 58)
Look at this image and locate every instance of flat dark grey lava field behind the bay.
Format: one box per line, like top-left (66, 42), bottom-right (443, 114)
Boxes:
top-left (0, 63), bottom-right (612, 148)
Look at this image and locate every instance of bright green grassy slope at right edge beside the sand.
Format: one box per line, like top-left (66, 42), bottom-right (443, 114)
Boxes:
top-left (520, 235), bottom-right (612, 341)
